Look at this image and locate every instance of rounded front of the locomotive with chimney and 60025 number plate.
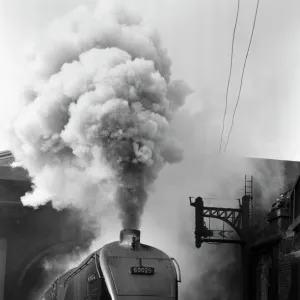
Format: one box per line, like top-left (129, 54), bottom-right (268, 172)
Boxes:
top-left (99, 229), bottom-right (180, 300)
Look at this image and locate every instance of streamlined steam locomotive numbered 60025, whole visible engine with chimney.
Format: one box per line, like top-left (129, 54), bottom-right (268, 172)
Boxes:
top-left (40, 229), bottom-right (181, 300)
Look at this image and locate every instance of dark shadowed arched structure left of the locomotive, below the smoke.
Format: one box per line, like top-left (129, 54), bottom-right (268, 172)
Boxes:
top-left (0, 151), bottom-right (92, 300)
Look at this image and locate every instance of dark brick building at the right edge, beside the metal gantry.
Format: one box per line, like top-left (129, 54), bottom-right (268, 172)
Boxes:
top-left (250, 173), bottom-right (300, 300)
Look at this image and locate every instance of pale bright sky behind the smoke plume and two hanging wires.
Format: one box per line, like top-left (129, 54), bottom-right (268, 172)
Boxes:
top-left (0, 0), bottom-right (300, 160)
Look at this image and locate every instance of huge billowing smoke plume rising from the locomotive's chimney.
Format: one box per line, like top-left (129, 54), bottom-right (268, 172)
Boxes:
top-left (11, 6), bottom-right (191, 228)
